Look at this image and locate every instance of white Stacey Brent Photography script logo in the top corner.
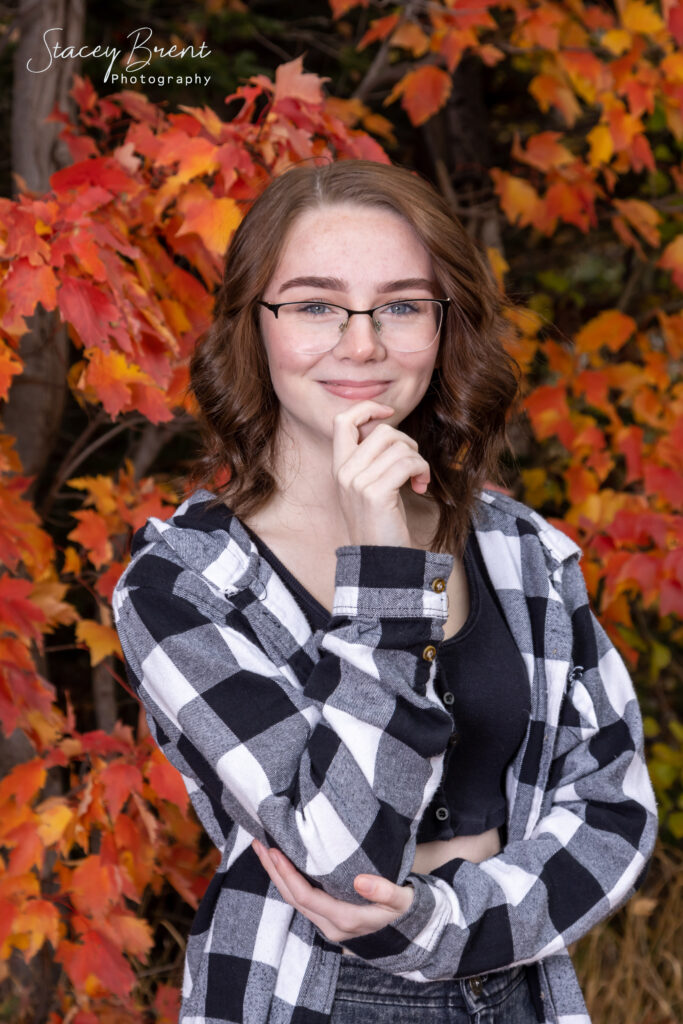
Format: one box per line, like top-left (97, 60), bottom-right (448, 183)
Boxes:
top-left (26, 26), bottom-right (211, 85)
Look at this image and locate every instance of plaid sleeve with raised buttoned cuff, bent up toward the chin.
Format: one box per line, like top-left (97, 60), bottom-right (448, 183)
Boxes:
top-left (114, 546), bottom-right (453, 902)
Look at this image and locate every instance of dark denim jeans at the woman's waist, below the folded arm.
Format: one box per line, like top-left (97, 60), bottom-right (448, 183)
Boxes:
top-left (330, 956), bottom-right (537, 1024)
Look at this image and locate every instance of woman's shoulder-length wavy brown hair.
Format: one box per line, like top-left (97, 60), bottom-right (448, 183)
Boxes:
top-left (190, 160), bottom-right (519, 552)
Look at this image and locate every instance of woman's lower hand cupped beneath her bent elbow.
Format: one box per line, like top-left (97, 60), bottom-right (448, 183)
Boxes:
top-left (252, 840), bottom-right (415, 942)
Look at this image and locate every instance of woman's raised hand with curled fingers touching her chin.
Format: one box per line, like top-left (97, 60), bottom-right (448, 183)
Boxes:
top-left (332, 398), bottom-right (429, 548)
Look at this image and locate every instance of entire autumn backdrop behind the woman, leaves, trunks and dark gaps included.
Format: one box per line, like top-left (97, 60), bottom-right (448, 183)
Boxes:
top-left (0, 0), bottom-right (683, 1024)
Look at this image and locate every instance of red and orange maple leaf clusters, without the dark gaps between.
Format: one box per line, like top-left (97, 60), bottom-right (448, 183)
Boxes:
top-left (0, 0), bottom-right (683, 1024)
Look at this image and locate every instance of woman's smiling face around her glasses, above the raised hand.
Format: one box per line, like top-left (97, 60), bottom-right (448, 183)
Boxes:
top-left (260, 204), bottom-right (440, 443)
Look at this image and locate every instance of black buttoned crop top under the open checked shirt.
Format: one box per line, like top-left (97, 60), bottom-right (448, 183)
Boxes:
top-left (243, 523), bottom-right (530, 843)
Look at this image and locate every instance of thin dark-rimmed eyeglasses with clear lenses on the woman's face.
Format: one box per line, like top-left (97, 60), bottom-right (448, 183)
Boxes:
top-left (253, 299), bottom-right (451, 354)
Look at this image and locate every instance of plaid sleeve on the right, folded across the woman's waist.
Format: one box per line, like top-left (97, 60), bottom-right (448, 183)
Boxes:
top-left (345, 557), bottom-right (656, 980)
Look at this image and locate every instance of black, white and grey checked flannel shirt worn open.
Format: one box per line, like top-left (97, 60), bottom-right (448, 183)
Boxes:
top-left (114, 490), bottom-right (656, 1024)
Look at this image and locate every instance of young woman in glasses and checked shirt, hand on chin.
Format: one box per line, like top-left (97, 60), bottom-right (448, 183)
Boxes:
top-left (115, 161), bottom-right (655, 1024)
